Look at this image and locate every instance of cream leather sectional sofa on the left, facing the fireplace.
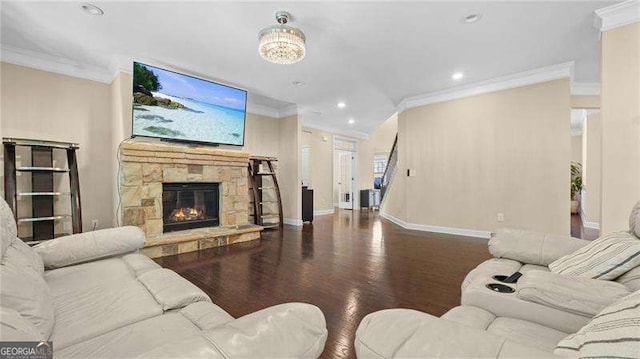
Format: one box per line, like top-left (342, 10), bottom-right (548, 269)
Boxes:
top-left (0, 201), bottom-right (327, 358)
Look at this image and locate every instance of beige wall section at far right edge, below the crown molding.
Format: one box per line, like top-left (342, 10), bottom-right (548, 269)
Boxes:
top-left (600, 22), bottom-right (640, 233)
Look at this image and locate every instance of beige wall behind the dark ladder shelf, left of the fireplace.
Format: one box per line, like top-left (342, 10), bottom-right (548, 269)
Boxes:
top-left (0, 63), bottom-right (116, 230)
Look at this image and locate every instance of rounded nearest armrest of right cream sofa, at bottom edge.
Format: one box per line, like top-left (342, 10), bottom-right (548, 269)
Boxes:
top-left (355, 309), bottom-right (557, 359)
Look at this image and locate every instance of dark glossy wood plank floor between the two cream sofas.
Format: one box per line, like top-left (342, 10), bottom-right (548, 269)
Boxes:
top-left (157, 211), bottom-right (490, 358)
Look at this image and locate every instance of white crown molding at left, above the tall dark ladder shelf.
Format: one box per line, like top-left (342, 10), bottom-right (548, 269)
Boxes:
top-left (0, 45), bottom-right (113, 84)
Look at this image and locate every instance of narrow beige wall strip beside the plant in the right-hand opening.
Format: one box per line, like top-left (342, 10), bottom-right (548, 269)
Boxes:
top-left (581, 113), bottom-right (602, 223)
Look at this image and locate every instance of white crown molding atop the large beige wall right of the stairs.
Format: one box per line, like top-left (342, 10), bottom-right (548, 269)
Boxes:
top-left (397, 61), bottom-right (574, 113)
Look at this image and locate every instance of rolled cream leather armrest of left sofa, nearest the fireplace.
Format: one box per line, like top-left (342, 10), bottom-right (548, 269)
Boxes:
top-left (33, 226), bottom-right (145, 268)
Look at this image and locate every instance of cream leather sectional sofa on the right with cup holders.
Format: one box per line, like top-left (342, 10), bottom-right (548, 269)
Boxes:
top-left (355, 202), bottom-right (640, 359)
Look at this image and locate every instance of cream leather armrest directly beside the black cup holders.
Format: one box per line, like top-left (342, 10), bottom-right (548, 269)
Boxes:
top-left (516, 270), bottom-right (631, 317)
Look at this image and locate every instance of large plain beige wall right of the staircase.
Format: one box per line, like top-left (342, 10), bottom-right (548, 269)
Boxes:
top-left (385, 79), bottom-right (571, 234)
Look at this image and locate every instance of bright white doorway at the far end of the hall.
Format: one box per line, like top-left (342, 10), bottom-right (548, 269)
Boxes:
top-left (334, 137), bottom-right (358, 209)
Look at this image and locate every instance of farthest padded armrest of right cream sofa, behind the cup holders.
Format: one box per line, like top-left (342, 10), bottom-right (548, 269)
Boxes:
top-left (489, 228), bottom-right (589, 266)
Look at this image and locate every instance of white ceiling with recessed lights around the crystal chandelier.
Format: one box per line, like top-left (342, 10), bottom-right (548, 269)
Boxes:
top-left (0, 1), bottom-right (619, 134)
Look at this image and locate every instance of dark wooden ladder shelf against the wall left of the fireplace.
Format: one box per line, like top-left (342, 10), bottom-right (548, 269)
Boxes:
top-left (2, 138), bottom-right (82, 244)
